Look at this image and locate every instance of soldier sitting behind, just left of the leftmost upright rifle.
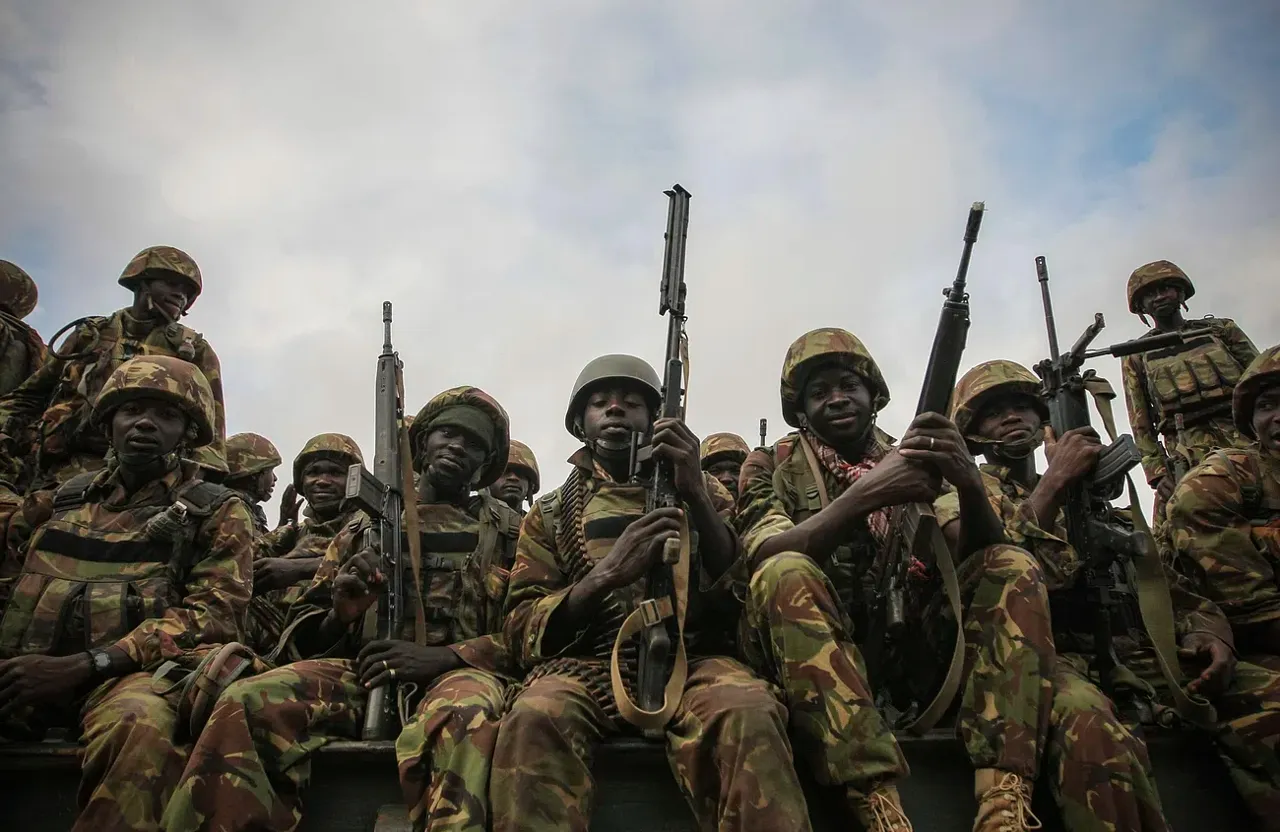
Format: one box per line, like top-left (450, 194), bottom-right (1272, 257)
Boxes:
top-left (244, 434), bottom-right (365, 654)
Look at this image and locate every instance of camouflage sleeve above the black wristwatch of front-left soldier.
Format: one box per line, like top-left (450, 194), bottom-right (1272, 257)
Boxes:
top-left (115, 497), bottom-right (253, 669)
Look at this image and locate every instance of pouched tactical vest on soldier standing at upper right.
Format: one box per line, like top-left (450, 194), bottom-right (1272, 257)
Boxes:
top-left (1142, 319), bottom-right (1244, 431)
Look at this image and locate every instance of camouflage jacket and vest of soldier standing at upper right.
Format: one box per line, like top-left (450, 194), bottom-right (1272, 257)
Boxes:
top-left (1120, 317), bottom-right (1258, 483)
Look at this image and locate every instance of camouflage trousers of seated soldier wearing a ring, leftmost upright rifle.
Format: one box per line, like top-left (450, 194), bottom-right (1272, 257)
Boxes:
top-left (164, 659), bottom-right (506, 832)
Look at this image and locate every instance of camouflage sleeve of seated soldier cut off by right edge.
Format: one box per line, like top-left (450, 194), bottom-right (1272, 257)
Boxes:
top-left (1167, 454), bottom-right (1280, 626)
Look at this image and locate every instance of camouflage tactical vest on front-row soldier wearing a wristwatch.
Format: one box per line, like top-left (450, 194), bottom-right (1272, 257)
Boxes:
top-left (0, 474), bottom-right (236, 657)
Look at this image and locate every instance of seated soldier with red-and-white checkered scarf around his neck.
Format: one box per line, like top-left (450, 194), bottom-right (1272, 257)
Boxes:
top-left (737, 329), bottom-right (1055, 832)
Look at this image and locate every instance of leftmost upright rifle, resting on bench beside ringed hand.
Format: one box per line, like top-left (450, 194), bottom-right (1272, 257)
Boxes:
top-left (344, 301), bottom-right (404, 740)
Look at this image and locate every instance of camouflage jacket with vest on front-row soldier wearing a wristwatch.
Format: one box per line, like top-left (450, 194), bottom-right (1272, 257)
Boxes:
top-left (0, 466), bottom-right (253, 669)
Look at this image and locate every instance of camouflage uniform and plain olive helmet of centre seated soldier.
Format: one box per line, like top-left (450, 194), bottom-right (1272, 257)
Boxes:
top-left (490, 356), bottom-right (809, 832)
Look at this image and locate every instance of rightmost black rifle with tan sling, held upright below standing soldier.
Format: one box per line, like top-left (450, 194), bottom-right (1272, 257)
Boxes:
top-left (1036, 257), bottom-right (1183, 721)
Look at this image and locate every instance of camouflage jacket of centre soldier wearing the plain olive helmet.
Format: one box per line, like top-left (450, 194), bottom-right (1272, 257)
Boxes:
top-left (504, 448), bottom-right (745, 669)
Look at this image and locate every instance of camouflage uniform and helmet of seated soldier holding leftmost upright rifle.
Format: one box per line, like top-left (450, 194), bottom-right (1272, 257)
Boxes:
top-left (164, 387), bottom-right (520, 832)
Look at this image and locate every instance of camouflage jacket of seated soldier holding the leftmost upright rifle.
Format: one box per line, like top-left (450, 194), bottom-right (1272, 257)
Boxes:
top-left (289, 493), bottom-right (520, 675)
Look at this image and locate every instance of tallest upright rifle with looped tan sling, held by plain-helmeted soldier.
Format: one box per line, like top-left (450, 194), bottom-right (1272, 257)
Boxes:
top-left (612, 184), bottom-right (690, 736)
